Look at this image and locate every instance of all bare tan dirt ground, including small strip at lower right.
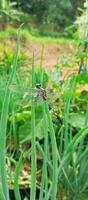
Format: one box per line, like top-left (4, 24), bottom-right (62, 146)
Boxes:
top-left (22, 38), bottom-right (78, 82)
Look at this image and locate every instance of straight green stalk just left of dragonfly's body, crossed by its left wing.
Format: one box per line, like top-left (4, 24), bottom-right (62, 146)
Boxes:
top-left (30, 51), bottom-right (36, 200)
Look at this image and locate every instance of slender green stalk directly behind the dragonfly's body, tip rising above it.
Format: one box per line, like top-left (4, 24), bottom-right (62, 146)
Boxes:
top-left (39, 47), bottom-right (48, 200)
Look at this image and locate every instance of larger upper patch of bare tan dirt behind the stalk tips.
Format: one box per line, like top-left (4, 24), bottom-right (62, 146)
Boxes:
top-left (23, 41), bottom-right (73, 69)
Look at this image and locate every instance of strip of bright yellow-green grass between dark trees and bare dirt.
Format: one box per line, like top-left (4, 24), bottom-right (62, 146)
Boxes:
top-left (0, 27), bottom-right (71, 43)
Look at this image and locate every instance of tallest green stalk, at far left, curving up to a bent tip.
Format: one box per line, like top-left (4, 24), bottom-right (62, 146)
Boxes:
top-left (0, 28), bottom-right (19, 200)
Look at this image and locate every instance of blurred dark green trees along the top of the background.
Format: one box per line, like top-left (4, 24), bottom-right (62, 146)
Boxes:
top-left (0, 0), bottom-right (85, 31)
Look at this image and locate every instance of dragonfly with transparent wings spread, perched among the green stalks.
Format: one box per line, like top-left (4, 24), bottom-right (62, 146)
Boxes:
top-left (0, 76), bottom-right (61, 107)
